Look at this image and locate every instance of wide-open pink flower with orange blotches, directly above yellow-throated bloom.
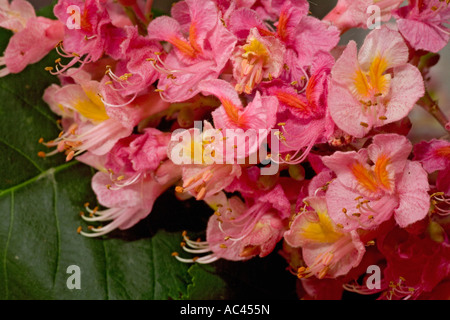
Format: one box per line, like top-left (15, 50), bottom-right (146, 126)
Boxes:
top-left (322, 134), bottom-right (430, 231)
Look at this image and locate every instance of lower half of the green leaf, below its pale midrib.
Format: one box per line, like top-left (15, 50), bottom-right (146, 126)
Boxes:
top-left (0, 158), bottom-right (195, 299)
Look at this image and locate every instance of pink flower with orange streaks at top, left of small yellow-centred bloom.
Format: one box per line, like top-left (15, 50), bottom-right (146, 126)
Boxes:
top-left (148, 0), bottom-right (236, 102)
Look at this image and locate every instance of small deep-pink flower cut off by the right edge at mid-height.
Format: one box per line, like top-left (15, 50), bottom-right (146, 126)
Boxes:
top-left (414, 139), bottom-right (450, 195)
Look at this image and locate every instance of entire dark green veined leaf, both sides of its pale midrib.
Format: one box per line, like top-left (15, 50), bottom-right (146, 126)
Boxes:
top-left (0, 26), bottom-right (191, 299)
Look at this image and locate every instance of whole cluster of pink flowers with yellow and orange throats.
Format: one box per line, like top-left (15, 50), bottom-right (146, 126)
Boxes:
top-left (0, 0), bottom-right (450, 299)
